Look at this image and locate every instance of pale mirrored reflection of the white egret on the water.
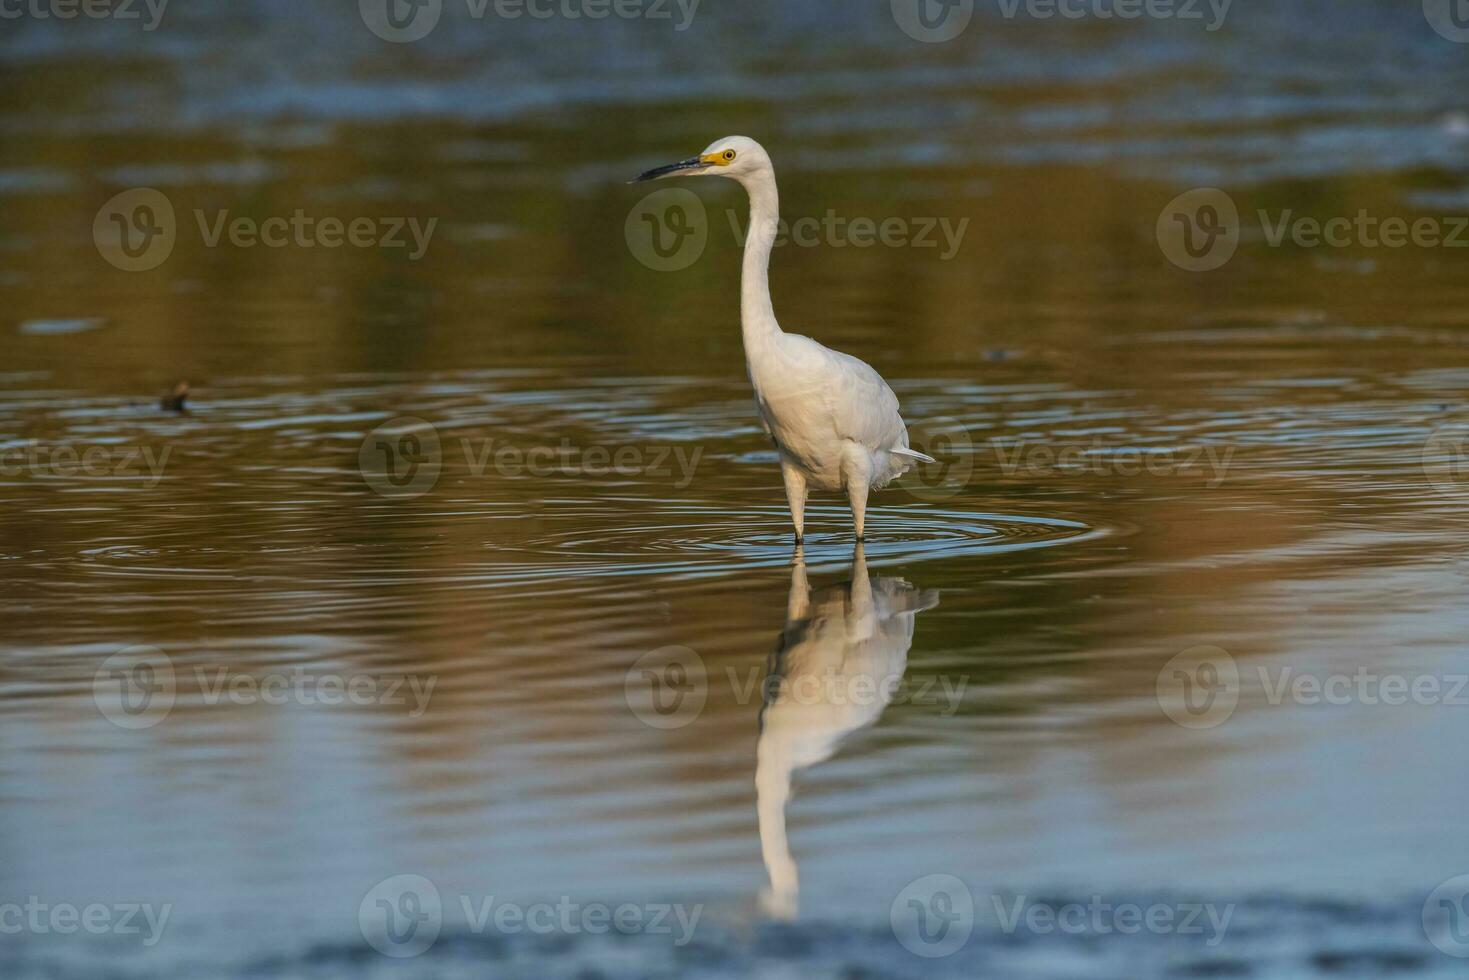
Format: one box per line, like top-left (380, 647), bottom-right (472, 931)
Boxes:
top-left (755, 544), bottom-right (939, 918)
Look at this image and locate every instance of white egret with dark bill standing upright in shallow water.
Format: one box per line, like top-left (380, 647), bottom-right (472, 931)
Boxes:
top-left (635, 137), bottom-right (934, 542)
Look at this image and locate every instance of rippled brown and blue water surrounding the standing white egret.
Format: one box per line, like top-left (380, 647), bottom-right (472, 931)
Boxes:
top-left (0, 1), bottom-right (1469, 977)
